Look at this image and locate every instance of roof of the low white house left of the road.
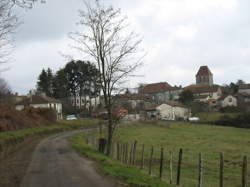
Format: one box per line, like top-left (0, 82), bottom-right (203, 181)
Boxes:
top-left (16, 95), bottom-right (61, 105)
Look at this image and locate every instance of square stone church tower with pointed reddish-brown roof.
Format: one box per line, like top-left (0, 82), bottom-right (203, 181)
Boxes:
top-left (196, 66), bottom-right (213, 86)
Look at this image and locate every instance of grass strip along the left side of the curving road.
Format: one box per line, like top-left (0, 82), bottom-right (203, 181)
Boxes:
top-left (0, 119), bottom-right (101, 145)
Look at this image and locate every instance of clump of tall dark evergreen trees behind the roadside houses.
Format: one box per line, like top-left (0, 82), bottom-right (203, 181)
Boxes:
top-left (37, 60), bottom-right (100, 106)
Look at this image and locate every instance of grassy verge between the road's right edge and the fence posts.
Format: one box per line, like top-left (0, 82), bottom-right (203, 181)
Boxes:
top-left (70, 133), bottom-right (173, 187)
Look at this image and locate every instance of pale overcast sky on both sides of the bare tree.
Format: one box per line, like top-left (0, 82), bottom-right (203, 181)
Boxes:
top-left (1, 0), bottom-right (250, 94)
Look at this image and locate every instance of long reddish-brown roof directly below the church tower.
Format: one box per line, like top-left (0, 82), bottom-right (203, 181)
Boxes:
top-left (184, 84), bottom-right (220, 94)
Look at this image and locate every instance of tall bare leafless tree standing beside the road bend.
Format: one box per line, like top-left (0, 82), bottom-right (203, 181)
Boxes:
top-left (69, 0), bottom-right (144, 154)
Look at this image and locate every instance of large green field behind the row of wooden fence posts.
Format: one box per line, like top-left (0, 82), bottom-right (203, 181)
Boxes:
top-left (88, 122), bottom-right (250, 187)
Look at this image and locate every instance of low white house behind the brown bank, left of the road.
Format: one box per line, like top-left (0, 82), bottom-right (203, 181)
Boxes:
top-left (15, 95), bottom-right (62, 119)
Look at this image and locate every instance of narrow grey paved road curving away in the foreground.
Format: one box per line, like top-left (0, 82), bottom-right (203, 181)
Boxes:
top-left (21, 131), bottom-right (119, 187)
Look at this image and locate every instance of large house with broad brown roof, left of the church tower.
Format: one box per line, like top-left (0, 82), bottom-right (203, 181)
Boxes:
top-left (139, 82), bottom-right (182, 103)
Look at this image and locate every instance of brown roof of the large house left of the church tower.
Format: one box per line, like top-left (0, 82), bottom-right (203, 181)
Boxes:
top-left (142, 82), bottom-right (178, 94)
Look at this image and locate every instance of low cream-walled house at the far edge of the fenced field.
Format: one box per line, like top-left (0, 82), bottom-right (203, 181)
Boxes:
top-left (146, 102), bottom-right (191, 120)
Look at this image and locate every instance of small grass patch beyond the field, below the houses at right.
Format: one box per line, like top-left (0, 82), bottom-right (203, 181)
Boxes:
top-left (195, 112), bottom-right (239, 122)
